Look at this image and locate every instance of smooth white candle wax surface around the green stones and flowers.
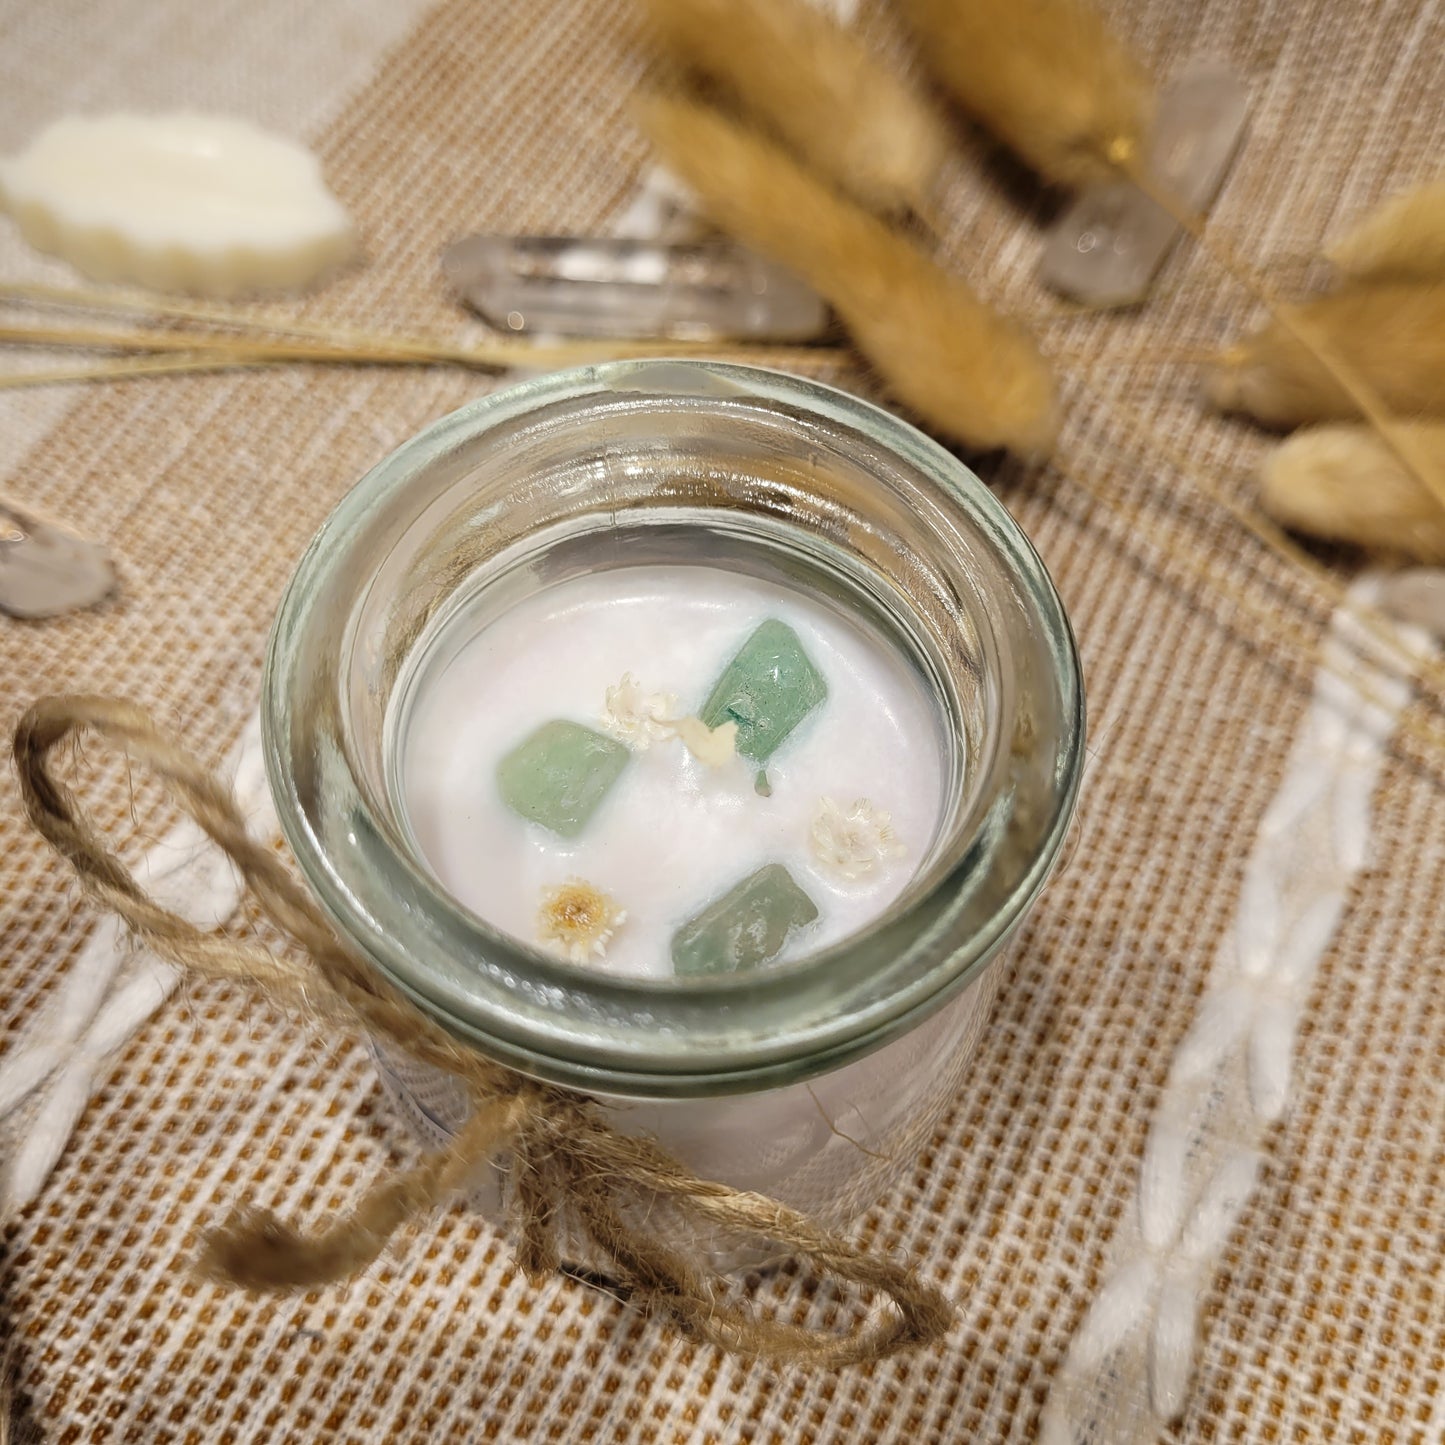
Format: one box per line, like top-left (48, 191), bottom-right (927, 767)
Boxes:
top-left (399, 565), bottom-right (944, 977)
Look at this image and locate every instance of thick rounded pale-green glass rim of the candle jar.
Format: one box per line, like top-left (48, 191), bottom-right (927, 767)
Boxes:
top-left (262, 360), bottom-right (1084, 1097)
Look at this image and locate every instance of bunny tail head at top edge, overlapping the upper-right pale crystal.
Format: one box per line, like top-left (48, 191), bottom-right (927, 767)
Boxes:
top-left (900, 0), bottom-right (1153, 188)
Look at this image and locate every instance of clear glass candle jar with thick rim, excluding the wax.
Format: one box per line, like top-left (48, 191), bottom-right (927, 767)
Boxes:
top-left (263, 361), bottom-right (1084, 1242)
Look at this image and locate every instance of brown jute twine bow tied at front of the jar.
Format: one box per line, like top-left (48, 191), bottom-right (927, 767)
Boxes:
top-left (14, 695), bottom-right (954, 1367)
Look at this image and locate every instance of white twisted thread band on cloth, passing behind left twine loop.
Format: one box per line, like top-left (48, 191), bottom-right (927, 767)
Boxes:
top-left (0, 715), bottom-right (279, 1220)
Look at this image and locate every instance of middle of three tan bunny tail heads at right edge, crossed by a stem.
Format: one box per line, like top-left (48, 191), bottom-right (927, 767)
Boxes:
top-left (1208, 286), bottom-right (1445, 427)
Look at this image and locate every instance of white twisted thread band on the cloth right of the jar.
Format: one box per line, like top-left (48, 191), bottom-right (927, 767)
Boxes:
top-left (1040, 572), bottom-right (1445, 1445)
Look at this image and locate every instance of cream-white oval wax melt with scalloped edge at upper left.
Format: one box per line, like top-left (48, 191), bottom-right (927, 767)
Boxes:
top-left (0, 113), bottom-right (355, 296)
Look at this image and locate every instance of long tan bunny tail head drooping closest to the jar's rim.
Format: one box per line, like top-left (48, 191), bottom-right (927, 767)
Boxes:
top-left (639, 98), bottom-right (1058, 455)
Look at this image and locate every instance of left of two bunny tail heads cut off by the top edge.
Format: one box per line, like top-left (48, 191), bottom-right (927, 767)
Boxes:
top-left (642, 0), bottom-right (948, 217)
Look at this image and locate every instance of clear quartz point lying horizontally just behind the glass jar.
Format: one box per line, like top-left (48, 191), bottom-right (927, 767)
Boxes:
top-left (442, 236), bottom-right (829, 341)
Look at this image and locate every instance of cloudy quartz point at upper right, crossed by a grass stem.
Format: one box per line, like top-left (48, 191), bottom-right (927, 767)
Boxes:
top-left (1039, 65), bottom-right (1248, 306)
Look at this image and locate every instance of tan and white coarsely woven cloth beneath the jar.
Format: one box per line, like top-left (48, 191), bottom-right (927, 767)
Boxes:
top-left (0, 0), bottom-right (1445, 1445)
